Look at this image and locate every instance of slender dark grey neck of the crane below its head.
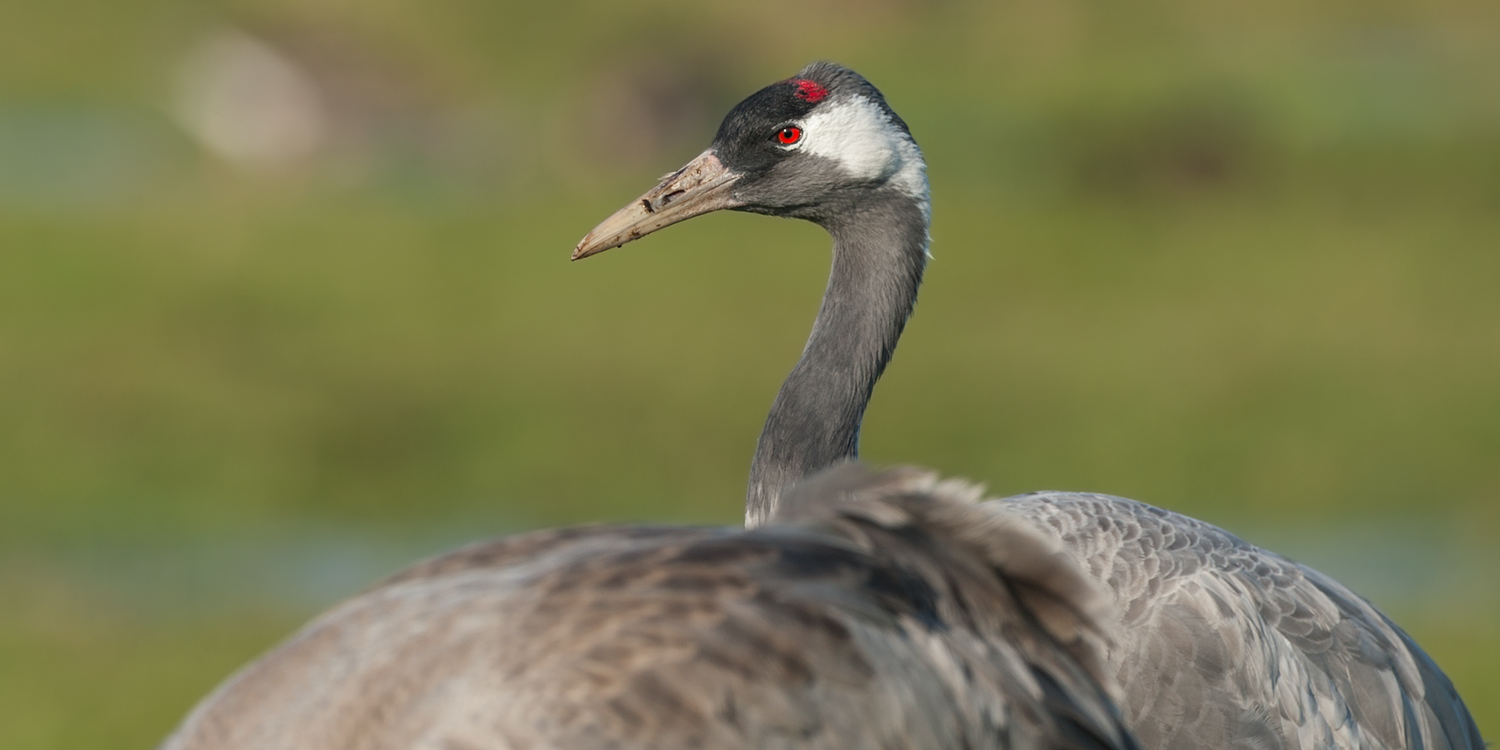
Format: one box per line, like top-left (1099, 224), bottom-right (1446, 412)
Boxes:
top-left (746, 192), bottom-right (927, 527)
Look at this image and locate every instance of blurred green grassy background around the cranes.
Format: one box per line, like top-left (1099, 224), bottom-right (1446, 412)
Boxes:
top-left (0, 0), bottom-right (1500, 749)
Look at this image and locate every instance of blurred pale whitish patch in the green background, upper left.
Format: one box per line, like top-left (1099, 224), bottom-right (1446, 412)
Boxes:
top-left (173, 30), bottom-right (329, 170)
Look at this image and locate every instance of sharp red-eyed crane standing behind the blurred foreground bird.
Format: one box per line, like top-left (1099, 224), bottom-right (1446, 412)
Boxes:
top-left (575, 63), bottom-right (1484, 750)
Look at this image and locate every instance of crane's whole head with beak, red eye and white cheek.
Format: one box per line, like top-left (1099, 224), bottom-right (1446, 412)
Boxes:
top-left (573, 63), bottom-right (927, 260)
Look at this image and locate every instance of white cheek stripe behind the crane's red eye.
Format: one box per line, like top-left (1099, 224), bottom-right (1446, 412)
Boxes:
top-left (798, 96), bottom-right (929, 212)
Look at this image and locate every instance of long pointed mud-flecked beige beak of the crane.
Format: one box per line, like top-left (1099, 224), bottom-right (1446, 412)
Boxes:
top-left (573, 152), bottom-right (740, 261)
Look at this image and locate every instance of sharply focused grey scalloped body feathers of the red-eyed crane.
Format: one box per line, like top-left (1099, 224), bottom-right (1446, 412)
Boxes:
top-left (987, 492), bottom-right (1485, 750)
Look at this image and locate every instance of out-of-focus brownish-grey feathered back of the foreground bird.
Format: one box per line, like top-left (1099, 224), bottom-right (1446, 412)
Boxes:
top-left (164, 465), bottom-right (1137, 750)
